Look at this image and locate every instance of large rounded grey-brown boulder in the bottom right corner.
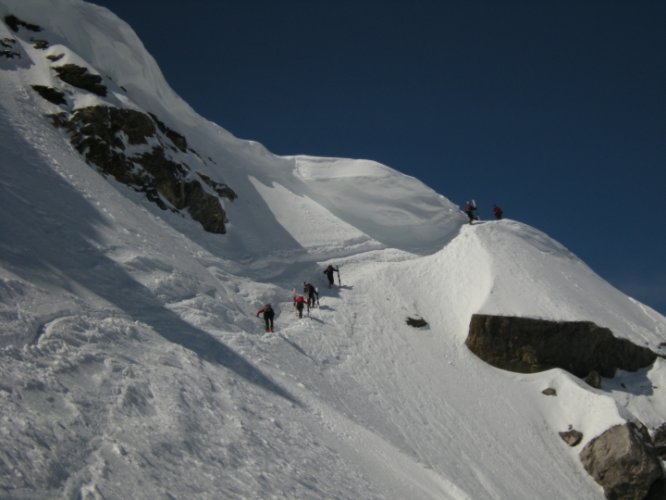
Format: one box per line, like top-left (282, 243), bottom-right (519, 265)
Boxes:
top-left (580, 423), bottom-right (663, 500)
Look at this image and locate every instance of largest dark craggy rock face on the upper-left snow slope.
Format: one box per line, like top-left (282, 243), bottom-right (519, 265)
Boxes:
top-left (51, 106), bottom-right (236, 233)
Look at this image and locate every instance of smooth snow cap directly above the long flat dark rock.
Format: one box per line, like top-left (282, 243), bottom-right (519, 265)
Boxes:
top-left (474, 221), bottom-right (666, 346)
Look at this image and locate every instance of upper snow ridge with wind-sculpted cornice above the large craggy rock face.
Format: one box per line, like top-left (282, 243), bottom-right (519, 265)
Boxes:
top-left (0, 0), bottom-right (462, 267)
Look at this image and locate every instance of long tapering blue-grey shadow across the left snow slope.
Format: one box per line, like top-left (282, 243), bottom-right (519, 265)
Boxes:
top-left (0, 122), bottom-right (300, 405)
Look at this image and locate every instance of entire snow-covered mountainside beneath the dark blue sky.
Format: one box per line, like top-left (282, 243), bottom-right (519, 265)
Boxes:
top-left (0, 0), bottom-right (666, 500)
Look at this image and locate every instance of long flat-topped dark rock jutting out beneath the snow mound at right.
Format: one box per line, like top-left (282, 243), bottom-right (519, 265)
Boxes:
top-left (465, 314), bottom-right (656, 377)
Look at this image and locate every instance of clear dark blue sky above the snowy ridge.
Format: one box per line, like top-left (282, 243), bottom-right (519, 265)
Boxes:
top-left (93, 0), bottom-right (666, 314)
